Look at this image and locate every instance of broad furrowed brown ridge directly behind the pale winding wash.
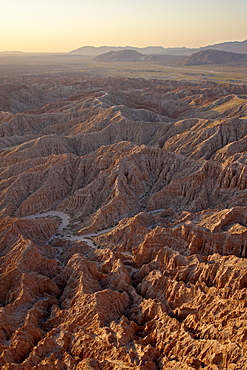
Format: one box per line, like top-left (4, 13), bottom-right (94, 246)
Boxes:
top-left (1, 142), bottom-right (246, 233)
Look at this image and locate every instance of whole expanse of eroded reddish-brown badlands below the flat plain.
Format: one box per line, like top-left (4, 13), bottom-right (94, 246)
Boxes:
top-left (0, 73), bottom-right (247, 370)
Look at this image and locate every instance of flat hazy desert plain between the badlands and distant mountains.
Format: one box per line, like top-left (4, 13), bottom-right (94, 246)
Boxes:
top-left (0, 53), bottom-right (247, 84)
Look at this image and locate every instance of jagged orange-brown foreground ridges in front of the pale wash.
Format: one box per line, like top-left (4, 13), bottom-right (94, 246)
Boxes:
top-left (0, 214), bottom-right (247, 369)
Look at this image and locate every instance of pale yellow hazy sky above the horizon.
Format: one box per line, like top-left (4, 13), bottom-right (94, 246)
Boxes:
top-left (0, 0), bottom-right (247, 52)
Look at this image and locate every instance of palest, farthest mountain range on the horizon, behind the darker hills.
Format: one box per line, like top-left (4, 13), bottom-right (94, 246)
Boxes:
top-left (70, 39), bottom-right (247, 56)
